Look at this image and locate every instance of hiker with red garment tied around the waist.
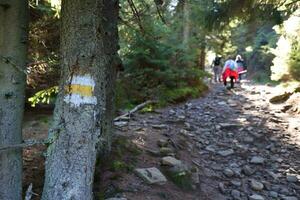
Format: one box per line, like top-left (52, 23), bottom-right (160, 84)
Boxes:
top-left (222, 57), bottom-right (238, 89)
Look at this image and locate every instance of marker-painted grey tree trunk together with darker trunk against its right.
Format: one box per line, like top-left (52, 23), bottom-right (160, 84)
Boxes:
top-left (42, 0), bottom-right (119, 200)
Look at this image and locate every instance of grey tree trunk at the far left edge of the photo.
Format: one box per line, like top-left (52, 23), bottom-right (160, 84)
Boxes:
top-left (0, 0), bottom-right (28, 200)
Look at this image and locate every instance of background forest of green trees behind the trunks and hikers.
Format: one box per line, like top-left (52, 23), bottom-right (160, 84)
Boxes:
top-left (28, 0), bottom-right (300, 111)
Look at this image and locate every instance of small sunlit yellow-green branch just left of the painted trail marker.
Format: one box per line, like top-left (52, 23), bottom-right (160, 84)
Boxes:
top-left (28, 86), bottom-right (58, 107)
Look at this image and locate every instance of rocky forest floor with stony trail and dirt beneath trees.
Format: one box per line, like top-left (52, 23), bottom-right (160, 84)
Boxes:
top-left (24, 83), bottom-right (300, 200)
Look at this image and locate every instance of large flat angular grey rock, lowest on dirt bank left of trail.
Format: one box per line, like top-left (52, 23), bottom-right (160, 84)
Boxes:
top-left (135, 167), bottom-right (167, 185)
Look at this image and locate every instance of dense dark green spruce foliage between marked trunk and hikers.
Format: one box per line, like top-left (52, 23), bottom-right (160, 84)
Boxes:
top-left (117, 7), bottom-right (207, 108)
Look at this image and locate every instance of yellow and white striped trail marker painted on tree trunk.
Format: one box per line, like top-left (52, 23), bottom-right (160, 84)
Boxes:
top-left (64, 74), bottom-right (97, 107)
